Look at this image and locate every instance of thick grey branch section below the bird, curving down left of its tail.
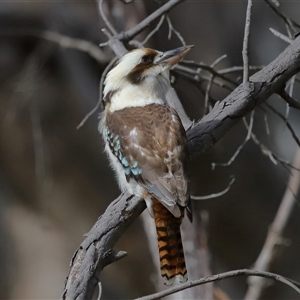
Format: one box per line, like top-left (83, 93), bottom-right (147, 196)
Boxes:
top-left (62, 193), bottom-right (146, 300)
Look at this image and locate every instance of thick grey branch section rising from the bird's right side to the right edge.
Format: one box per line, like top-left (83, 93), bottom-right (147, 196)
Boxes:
top-left (187, 37), bottom-right (300, 157)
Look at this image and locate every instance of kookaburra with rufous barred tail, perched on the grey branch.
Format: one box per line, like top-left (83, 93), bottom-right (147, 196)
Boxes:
top-left (99, 46), bottom-right (192, 285)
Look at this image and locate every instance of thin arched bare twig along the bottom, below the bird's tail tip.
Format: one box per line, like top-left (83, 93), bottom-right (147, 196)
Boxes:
top-left (136, 269), bottom-right (300, 300)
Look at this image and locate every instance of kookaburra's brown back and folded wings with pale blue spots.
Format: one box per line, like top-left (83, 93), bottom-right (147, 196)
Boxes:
top-left (106, 104), bottom-right (189, 217)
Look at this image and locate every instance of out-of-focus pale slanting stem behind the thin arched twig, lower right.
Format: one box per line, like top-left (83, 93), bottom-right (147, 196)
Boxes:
top-left (245, 148), bottom-right (300, 300)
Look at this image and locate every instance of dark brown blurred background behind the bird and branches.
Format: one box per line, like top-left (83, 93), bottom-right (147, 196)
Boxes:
top-left (0, 0), bottom-right (300, 299)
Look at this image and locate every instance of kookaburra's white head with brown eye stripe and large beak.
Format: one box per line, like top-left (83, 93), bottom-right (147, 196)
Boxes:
top-left (104, 46), bottom-right (193, 105)
